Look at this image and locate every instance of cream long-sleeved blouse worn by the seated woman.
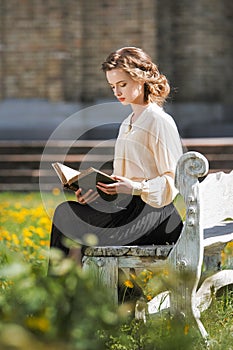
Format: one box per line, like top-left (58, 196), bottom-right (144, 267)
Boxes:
top-left (113, 103), bottom-right (182, 207)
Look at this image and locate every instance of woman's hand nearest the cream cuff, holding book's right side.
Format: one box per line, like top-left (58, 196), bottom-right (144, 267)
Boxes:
top-left (96, 176), bottom-right (133, 195)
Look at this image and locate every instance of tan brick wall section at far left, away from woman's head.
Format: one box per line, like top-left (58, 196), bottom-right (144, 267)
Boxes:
top-left (0, 0), bottom-right (82, 101)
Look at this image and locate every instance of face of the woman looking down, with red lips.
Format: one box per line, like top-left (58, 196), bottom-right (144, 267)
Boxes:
top-left (106, 69), bottom-right (145, 105)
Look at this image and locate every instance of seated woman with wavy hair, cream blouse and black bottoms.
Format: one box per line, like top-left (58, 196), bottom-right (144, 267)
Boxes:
top-left (51, 47), bottom-right (182, 255)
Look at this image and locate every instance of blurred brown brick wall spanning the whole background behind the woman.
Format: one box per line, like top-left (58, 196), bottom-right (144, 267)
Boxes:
top-left (0, 0), bottom-right (233, 103)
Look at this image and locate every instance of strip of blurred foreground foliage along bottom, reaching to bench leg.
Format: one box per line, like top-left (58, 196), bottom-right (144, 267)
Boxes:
top-left (0, 245), bottom-right (206, 350)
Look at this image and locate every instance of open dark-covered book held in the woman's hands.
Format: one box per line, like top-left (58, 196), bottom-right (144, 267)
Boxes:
top-left (52, 163), bottom-right (117, 201)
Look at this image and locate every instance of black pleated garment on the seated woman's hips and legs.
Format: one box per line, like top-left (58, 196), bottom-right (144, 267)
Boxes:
top-left (50, 196), bottom-right (183, 255)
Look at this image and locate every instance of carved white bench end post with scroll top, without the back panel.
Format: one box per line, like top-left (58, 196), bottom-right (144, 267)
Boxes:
top-left (168, 152), bottom-right (209, 317)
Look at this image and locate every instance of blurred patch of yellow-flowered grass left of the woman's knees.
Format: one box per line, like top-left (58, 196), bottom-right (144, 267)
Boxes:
top-left (0, 192), bottom-right (58, 269)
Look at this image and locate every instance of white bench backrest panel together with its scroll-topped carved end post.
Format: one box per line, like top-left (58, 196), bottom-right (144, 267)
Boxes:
top-left (168, 152), bottom-right (233, 315)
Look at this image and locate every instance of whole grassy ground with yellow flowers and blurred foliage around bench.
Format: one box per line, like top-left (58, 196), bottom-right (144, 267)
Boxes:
top-left (0, 189), bottom-right (233, 350)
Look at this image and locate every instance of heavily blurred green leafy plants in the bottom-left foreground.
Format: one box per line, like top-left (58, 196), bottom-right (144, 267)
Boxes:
top-left (0, 246), bottom-right (127, 350)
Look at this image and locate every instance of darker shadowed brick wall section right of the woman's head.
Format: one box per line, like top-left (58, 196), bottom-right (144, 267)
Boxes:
top-left (158, 0), bottom-right (233, 103)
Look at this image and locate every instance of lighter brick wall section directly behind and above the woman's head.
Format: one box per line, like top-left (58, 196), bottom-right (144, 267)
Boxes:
top-left (75, 0), bottom-right (156, 100)
